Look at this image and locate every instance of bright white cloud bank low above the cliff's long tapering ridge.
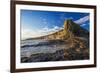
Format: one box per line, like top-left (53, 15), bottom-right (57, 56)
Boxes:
top-left (21, 26), bottom-right (62, 39)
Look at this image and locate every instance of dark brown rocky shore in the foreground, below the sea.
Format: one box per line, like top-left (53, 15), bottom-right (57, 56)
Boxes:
top-left (21, 38), bottom-right (89, 63)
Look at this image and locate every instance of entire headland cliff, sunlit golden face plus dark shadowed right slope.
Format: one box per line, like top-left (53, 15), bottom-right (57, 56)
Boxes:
top-left (29, 19), bottom-right (89, 40)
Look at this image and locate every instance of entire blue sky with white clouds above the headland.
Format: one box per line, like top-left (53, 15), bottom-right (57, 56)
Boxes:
top-left (21, 10), bottom-right (89, 39)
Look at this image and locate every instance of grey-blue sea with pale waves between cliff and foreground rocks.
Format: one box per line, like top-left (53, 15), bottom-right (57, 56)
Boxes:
top-left (21, 39), bottom-right (67, 57)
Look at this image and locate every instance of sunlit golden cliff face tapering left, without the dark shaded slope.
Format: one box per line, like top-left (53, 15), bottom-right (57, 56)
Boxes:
top-left (32, 20), bottom-right (72, 40)
